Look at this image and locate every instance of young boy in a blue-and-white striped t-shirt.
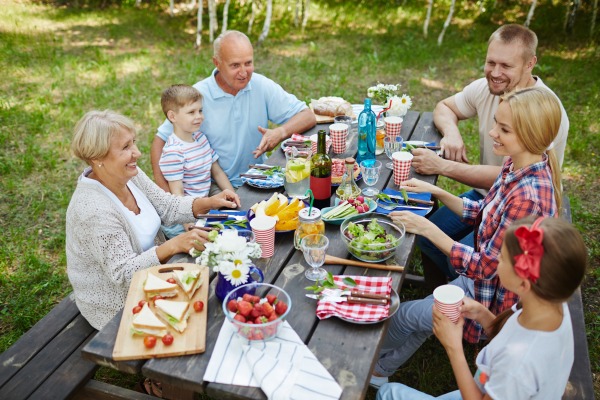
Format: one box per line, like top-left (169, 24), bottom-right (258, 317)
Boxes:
top-left (159, 85), bottom-right (234, 238)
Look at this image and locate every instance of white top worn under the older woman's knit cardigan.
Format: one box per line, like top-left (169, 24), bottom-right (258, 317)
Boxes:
top-left (82, 170), bottom-right (160, 251)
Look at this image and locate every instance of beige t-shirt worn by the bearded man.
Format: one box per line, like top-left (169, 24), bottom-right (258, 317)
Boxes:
top-left (454, 76), bottom-right (569, 196)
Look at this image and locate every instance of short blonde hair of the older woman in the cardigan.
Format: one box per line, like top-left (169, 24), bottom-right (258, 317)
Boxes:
top-left (71, 110), bottom-right (136, 165)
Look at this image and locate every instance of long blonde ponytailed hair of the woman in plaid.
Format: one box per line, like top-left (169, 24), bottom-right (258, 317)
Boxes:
top-left (502, 87), bottom-right (562, 212)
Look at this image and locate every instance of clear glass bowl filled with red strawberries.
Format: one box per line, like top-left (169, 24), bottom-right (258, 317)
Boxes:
top-left (223, 282), bottom-right (292, 341)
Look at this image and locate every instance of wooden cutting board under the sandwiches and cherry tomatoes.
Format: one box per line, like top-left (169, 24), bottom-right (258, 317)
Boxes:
top-left (113, 263), bottom-right (210, 361)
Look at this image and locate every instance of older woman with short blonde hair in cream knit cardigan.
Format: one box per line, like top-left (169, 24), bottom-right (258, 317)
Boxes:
top-left (66, 110), bottom-right (240, 329)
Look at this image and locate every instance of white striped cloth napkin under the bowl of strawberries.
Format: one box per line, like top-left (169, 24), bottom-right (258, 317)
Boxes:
top-left (204, 319), bottom-right (342, 400)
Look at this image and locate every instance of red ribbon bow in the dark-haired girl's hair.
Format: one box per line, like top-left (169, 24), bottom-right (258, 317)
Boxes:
top-left (515, 217), bottom-right (544, 283)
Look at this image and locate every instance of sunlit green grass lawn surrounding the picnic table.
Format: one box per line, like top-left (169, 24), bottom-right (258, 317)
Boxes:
top-left (0, 0), bottom-right (600, 398)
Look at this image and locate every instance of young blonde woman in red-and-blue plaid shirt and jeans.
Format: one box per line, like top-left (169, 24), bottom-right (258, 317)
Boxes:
top-left (371, 87), bottom-right (561, 387)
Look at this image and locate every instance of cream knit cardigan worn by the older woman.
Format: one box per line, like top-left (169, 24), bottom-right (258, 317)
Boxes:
top-left (66, 168), bottom-right (194, 329)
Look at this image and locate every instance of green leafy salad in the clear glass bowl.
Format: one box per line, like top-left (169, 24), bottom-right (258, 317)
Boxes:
top-left (344, 219), bottom-right (400, 261)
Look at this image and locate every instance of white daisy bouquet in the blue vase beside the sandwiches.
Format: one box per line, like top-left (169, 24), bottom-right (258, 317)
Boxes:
top-left (196, 229), bottom-right (261, 286)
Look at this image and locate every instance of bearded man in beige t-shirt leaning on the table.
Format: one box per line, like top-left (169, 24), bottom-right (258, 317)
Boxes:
top-left (412, 24), bottom-right (569, 288)
